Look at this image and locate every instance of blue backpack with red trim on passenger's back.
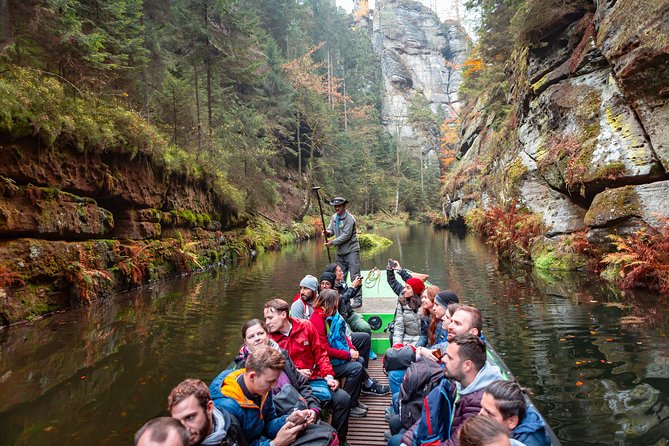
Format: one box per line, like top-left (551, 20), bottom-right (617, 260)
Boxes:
top-left (413, 379), bottom-right (457, 446)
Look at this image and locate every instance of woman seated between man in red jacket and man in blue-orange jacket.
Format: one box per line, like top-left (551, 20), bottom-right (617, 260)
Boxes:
top-left (234, 319), bottom-right (321, 422)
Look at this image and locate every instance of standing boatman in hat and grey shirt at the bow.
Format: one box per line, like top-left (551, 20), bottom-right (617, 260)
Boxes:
top-left (323, 197), bottom-right (362, 308)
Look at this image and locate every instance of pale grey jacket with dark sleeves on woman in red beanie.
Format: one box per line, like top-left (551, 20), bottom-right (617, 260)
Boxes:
top-left (386, 269), bottom-right (421, 345)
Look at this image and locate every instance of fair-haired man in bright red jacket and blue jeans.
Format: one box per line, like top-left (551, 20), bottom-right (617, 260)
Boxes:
top-left (263, 299), bottom-right (351, 443)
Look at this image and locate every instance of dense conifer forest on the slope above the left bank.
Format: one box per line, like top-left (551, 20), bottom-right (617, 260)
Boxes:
top-left (0, 0), bottom-right (438, 221)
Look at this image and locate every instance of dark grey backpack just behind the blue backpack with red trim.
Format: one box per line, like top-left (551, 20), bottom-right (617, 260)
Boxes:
top-left (399, 358), bottom-right (444, 429)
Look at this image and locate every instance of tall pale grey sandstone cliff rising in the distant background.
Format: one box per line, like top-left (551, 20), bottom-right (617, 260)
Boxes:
top-left (373, 0), bottom-right (469, 152)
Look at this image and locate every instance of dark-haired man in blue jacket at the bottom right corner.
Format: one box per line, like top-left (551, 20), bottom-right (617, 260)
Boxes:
top-left (479, 381), bottom-right (551, 446)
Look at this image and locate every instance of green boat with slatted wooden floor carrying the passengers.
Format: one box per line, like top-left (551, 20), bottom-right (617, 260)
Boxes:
top-left (348, 268), bottom-right (561, 446)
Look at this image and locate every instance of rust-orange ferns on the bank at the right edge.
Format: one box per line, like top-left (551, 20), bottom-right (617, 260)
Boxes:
top-left (602, 218), bottom-right (669, 294)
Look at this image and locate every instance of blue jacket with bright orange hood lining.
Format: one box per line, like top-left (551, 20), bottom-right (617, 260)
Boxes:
top-left (209, 369), bottom-right (286, 446)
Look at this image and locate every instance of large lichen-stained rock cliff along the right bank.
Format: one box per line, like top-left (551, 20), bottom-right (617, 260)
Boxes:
top-left (447, 0), bottom-right (669, 253)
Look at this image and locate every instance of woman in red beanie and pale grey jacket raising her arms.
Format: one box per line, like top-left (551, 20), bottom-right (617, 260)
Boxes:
top-left (386, 259), bottom-right (425, 345)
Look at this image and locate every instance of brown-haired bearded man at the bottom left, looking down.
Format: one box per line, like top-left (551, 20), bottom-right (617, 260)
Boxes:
top-left (167, 379), bottom-right (246, 446)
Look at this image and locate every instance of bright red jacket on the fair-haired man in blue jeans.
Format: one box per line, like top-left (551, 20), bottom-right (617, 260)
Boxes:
top-left (270, 317), bottom-right (335, 379)
